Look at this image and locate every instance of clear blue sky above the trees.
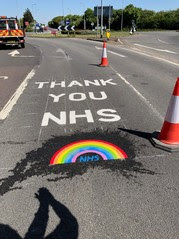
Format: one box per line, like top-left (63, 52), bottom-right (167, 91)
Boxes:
top-left (0, 0), bottom-right (179, 24)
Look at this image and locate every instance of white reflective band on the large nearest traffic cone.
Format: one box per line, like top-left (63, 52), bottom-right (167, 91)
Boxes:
top-left (165, 95), bottom-right (179, 124)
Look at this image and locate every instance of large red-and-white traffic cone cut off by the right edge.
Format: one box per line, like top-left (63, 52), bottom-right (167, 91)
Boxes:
top-left (151, 77), bottom-right (179, 152)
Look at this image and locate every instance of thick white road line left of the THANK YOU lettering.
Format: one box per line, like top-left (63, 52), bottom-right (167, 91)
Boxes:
top-left (0, 69), bottom-right (35, 120)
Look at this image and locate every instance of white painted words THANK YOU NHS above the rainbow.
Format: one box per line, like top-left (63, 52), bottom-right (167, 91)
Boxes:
top-left (35, 79), bottom-right (121, 127)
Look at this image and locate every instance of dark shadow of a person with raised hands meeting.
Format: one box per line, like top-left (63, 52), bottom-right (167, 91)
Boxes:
top-left (0, 188), bottom-right (78, 239)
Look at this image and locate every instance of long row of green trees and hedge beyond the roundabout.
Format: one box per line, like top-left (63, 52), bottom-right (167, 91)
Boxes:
top-left (48, 4), bottom-right (179, 30)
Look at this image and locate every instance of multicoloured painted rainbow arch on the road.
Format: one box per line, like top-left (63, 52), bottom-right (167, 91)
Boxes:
top-left (50, 140), bottom-right (128, 165)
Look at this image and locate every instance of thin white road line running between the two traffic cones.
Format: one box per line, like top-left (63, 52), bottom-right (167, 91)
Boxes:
top-left (111, 67), bottom-right (164, 121)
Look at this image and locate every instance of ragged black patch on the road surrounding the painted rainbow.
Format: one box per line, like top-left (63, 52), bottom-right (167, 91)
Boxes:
top-left (0, 130), bottom-right (155, 195)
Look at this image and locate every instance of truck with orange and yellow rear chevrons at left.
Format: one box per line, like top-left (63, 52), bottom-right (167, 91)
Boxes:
top-left (0, 16), bottom-right (25, 48)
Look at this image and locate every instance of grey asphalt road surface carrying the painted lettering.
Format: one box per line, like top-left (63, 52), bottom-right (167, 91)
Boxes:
top-left (0, 32), bottom-right (179, 239)
